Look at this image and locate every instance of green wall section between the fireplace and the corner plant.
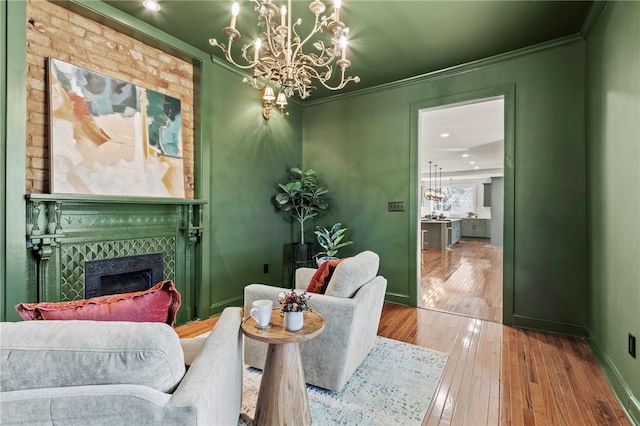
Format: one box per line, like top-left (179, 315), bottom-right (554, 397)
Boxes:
top-left (204, 60), bottom-right (302, 312)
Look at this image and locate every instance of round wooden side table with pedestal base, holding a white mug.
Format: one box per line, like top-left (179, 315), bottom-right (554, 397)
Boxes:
top-left (241, 308), bottom-right (324, 426)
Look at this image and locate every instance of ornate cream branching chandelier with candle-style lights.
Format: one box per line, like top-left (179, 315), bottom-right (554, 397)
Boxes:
top-left (209, 0), bottom-right (360, 118)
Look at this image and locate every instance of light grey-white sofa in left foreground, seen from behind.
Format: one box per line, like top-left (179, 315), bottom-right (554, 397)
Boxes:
top-left (0, 308), bottom-right (243, 426)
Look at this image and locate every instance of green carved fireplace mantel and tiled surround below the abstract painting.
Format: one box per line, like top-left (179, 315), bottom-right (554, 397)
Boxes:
top-left (26, 194), bottom-right (205, 323)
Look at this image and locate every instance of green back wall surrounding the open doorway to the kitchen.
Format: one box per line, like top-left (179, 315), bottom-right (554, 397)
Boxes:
top-left (303, 42), bottom-right (587, 332)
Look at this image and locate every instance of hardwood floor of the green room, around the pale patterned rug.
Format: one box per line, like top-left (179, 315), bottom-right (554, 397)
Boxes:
top-left (176, 303), bottom-right (631, 426)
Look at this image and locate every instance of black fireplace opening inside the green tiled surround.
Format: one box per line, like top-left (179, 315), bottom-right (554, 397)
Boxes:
top-left (84, 253), bottom-right (163, 299)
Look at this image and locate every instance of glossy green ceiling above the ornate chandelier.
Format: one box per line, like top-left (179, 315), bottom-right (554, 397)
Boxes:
top-left (103, 0), bottom-right (592, 100)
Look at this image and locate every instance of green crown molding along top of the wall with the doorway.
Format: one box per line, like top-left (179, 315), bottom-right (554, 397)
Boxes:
top-left (302, 33), bottom-right (584, 107)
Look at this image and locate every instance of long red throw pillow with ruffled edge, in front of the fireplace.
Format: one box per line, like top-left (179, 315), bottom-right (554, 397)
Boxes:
top-left (16, 280), bottom-right (181, 325)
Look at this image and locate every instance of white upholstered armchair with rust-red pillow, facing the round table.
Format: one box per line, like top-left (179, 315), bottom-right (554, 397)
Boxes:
top-left (244, 251), bottom-right (387, 392)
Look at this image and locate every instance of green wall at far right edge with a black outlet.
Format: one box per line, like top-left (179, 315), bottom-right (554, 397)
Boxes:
top-left (587, 2), bottom-right (640, 423)
